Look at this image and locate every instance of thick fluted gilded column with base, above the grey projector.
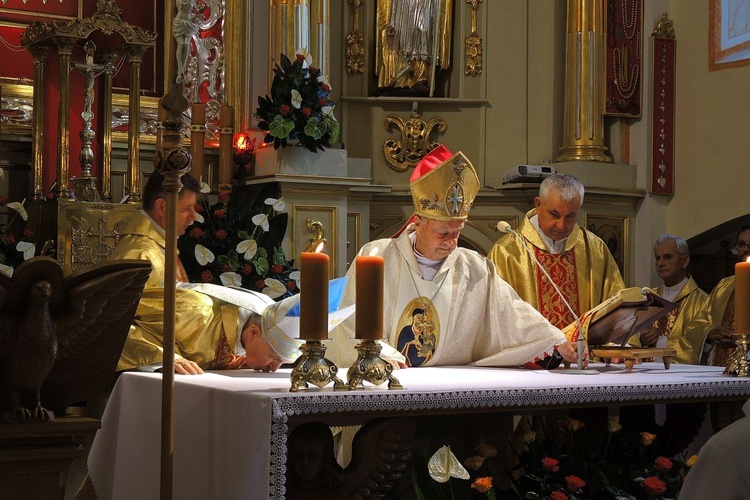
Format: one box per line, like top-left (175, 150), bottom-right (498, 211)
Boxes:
top-left (557, 0), bottom-right (612, 162)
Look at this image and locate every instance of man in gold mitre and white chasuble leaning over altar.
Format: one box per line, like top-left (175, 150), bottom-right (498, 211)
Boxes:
top-left (328, 146), bottom-right (588, 366)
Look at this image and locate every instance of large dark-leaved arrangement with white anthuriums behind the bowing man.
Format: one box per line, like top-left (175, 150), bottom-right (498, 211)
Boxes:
top-left (177, 184), bottom-right (300, 300)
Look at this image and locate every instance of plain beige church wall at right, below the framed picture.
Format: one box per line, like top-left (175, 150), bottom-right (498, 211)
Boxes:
top-left (667, 0), bottom-right (750, 238)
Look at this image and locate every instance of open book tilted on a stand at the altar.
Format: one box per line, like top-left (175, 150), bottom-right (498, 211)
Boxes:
top-left (563, 287), bottom-right (677, 346)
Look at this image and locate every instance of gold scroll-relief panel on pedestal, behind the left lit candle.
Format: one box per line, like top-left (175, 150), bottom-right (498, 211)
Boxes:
top-left (291, 205), bottom-right (339, 278)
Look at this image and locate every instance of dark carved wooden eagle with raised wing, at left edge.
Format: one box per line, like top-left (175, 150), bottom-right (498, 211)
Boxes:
top-left (0, 257), bottom-right (151, 422)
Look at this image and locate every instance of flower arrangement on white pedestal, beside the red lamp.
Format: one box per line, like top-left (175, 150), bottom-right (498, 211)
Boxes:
top-left (255, 52), bottom-right (340, 153)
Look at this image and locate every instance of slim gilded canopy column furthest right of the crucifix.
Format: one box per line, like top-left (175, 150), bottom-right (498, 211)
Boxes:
top-left (125, 45), bottom-right (145, 203)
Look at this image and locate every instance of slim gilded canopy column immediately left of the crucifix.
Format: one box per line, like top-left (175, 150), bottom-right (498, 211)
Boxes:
top-left (55, 38), bottom-right (73, 198)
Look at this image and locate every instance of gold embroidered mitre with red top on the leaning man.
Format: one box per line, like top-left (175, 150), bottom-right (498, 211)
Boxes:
top-left (410, 145), bottom-right (479, 221)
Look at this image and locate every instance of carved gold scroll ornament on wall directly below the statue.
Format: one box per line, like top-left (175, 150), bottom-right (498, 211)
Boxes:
top-left (383, 103), bottom-right (448, 172)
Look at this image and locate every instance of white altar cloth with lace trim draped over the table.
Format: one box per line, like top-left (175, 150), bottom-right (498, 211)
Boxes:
top-left (88, 363), bottom-right (750, 500)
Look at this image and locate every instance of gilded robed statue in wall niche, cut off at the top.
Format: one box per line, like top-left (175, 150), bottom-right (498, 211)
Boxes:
top-left (375, 0), bottom-right (453, 96)
